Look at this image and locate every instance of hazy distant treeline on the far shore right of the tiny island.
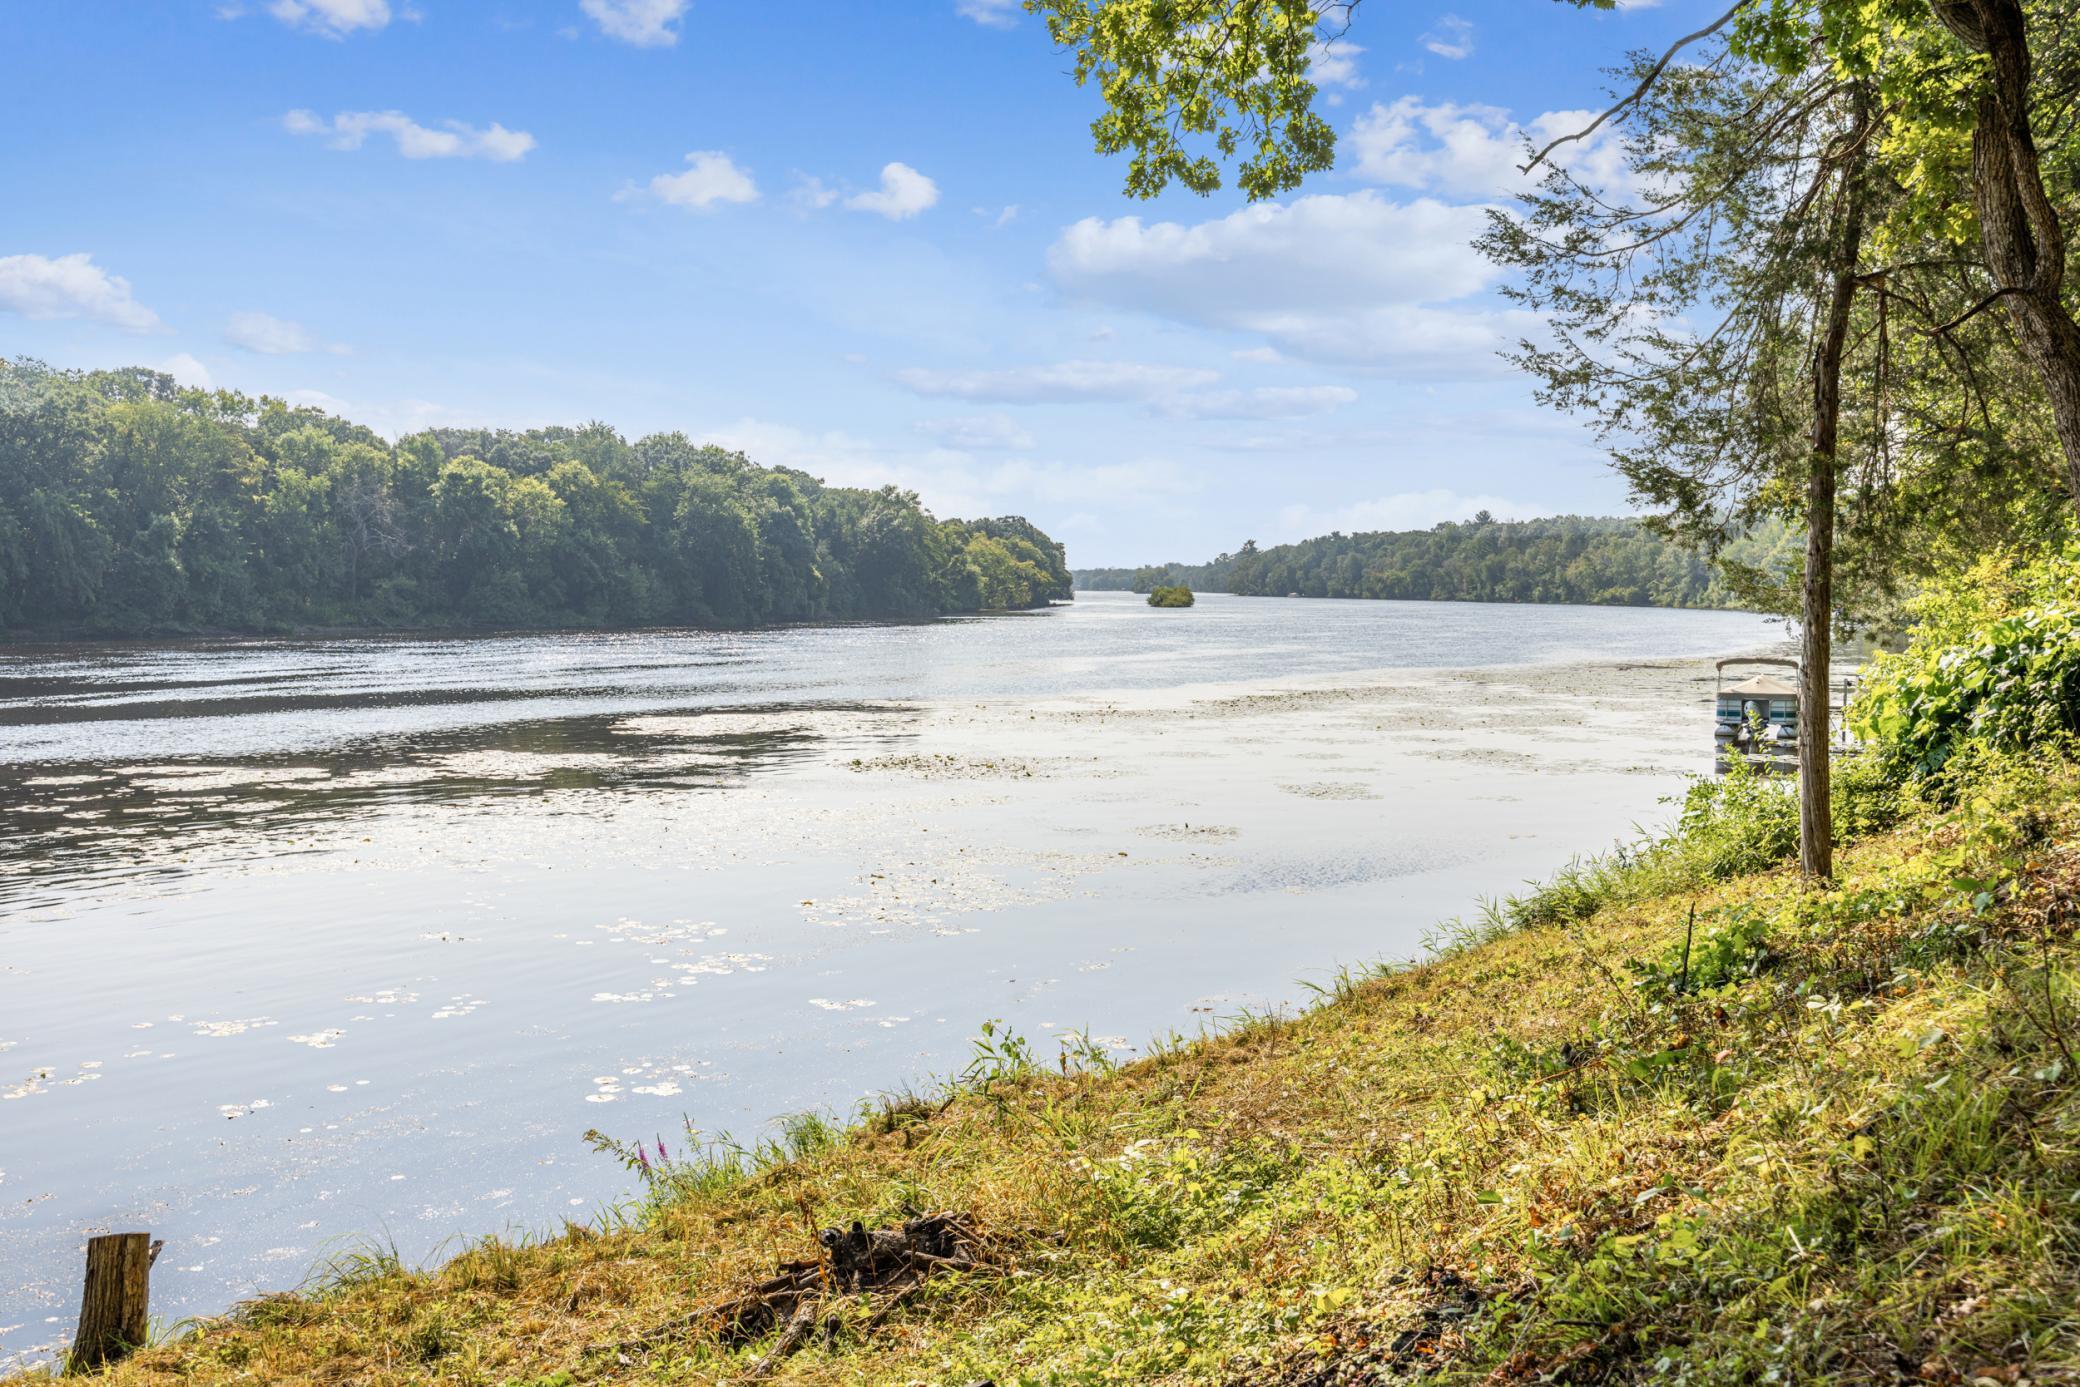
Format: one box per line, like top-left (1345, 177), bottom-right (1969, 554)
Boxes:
top-left (1075, 514), bottom-right (1795, 607)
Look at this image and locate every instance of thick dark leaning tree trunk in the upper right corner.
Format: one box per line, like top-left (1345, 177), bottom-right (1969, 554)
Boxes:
top-left (1930, 0), bottom-right (2080, 507)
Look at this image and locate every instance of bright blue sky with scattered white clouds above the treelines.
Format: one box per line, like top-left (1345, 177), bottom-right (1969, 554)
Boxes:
top-left (0, 0), bottom-right (1701, 564)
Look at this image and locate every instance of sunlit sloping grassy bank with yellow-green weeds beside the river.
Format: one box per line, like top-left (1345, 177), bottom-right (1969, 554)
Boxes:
top-left (24, 744), bottom-right (2080, 1385)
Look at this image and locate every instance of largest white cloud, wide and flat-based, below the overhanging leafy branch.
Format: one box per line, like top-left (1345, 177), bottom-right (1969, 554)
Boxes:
top-left (1048, 191), bottom-right (1535, 376)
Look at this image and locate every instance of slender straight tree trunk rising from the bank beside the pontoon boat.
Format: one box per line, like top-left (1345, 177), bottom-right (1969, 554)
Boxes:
top-left (1799, 85), bottom-right (1870, 882)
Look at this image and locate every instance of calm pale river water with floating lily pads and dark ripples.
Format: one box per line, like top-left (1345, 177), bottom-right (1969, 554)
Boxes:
top-left (0, 593), bottom-right (1780, 1364)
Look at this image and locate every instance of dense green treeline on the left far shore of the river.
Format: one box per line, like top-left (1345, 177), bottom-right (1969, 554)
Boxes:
top-left (0, 362), bottom-right (1069, 634)
